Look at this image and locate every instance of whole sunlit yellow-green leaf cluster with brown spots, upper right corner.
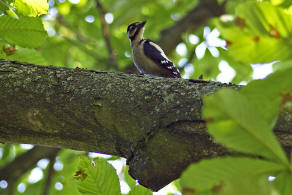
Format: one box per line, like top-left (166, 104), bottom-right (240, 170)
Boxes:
top-left (215, 1), bottom-right (292, 63)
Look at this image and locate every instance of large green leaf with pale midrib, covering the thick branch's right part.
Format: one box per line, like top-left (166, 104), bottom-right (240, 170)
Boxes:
top-left (203, 89), bottom-right (288, 164)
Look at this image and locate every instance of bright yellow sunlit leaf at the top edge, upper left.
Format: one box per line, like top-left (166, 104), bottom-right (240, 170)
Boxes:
top-left (15, 0), bottom-right (49, 17)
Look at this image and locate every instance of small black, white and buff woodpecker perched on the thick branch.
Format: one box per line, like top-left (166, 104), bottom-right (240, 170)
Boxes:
top-left (127, 21), bottom-right (181, 78)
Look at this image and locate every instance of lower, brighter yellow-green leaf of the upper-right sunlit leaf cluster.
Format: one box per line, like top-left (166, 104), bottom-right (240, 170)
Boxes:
top-left (216, 20), bottom-right (292, 64)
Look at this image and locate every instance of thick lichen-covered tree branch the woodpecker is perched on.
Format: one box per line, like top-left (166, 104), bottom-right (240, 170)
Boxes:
top-left (0, 60), bottom-right (292, 191)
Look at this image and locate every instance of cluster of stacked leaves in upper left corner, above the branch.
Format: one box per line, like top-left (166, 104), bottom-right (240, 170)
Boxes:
top-left (0, 0), bottom-right (48, 64)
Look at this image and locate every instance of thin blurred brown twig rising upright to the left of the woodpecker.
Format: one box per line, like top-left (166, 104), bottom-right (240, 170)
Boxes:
top-left (95, 0), bottom-right (118, 70)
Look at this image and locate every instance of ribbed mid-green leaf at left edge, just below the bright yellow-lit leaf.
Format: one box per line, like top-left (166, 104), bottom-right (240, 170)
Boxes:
top-left (0, 16), bottom-right (47, 48)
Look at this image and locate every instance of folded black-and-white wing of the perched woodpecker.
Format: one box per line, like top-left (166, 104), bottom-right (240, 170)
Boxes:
top-left (143, 40), bottom-right (181, 78)
